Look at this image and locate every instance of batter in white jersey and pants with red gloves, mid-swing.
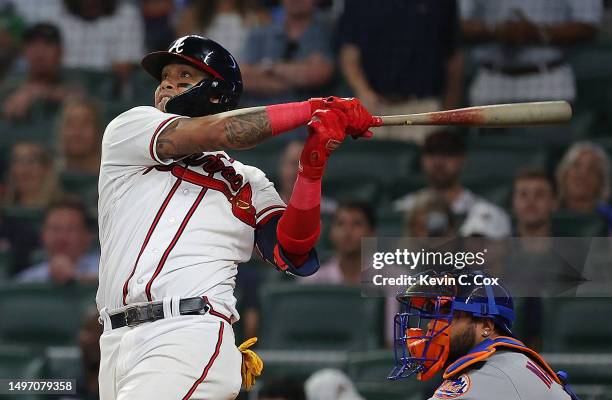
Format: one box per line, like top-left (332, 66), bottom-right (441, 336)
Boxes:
top-left (96, 36), bottom-right (372, 400)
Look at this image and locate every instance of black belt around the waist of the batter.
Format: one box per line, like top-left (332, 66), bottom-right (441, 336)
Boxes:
top-left (109, 297), bottom-right (210, 329)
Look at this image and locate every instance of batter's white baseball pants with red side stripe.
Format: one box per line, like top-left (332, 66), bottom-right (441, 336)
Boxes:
top-left (99, 298), bottom-right (242, 400)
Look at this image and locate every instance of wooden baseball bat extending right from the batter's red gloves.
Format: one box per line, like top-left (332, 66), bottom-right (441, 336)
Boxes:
top-left (374, 101), bottom-right (572, 128)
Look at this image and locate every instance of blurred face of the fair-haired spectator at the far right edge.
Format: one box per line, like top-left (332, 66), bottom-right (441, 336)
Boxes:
top-left (563, 150), bottom-right (603, 205)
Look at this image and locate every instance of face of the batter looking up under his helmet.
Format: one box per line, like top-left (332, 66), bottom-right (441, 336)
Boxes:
top-left (155, 64), bottom-right (208, 111)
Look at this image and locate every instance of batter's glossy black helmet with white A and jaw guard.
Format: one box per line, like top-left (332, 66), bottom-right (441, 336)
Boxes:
top-left (141, 35), bottom-right (242, 117)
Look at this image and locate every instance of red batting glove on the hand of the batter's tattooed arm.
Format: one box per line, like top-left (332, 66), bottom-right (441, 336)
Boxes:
top-left (308, 96), bottom-right (379, 139)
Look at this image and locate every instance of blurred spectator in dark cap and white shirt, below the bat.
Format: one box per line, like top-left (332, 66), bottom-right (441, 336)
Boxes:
top-left (393, 131), bottom-right (510, 238)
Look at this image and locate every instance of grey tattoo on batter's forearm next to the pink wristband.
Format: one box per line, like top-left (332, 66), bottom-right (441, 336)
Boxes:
top-left (225, 110), bottom-right (272, 148)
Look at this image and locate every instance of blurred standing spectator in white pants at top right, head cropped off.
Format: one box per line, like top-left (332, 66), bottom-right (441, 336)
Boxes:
top-left (460, 0), bottom-right (603, 104)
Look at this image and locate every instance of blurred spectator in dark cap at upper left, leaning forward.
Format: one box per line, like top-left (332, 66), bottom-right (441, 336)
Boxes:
top-left (2, 23), bottom-right (73, 120)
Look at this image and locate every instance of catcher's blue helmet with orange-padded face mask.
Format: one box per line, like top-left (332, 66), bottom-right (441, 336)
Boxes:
top-left (389, 271), bottom-right (514, 380)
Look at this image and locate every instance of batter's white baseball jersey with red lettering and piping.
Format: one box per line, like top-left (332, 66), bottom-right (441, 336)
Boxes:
top-left (96, 106), bottom-right (285, 320)
